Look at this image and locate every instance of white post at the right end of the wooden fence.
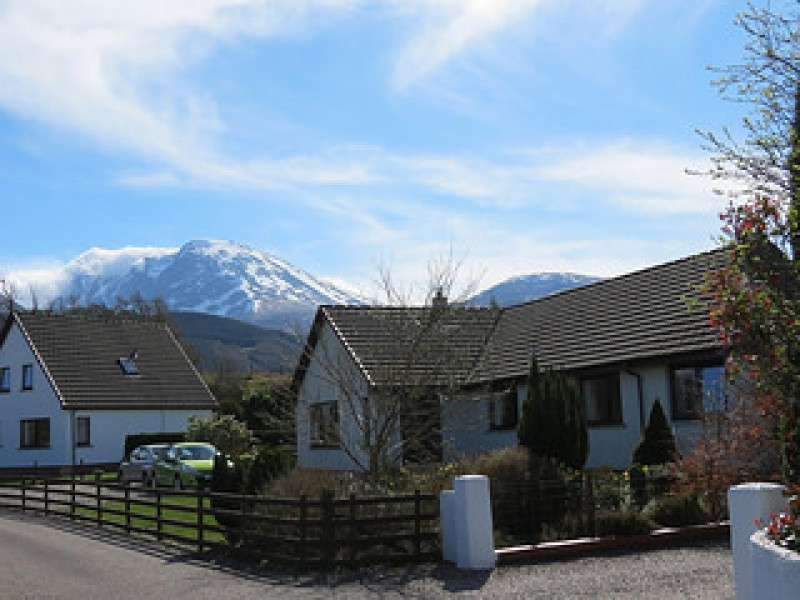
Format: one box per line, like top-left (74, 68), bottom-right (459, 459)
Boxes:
top-left (455, 475), bottom-right (497, 569)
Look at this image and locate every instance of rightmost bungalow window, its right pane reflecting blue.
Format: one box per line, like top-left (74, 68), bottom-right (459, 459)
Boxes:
top-left (672, 365), bottom-right (728, 419)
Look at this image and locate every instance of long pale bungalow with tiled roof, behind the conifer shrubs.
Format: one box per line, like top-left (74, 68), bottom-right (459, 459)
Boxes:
top-left (294, 251), bottom-right (726, 469)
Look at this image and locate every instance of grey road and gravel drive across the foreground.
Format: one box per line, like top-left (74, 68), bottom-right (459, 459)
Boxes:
top-left (0, 512), bottom-right (734, 600)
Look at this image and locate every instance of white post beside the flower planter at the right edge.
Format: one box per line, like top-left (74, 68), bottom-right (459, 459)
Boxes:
top-left (728, 483), bottom-right (787, 600)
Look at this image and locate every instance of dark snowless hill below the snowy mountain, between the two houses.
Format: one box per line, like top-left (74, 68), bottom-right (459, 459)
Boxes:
top-left (169, 312), bottom-right (301, 373)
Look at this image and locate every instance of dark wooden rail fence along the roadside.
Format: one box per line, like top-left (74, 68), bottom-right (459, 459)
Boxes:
top-left (0, 474), bottom-right (440, 568)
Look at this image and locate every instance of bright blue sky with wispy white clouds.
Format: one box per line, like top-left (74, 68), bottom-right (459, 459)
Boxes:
top-left (0, 0), bottom-right (764, 298)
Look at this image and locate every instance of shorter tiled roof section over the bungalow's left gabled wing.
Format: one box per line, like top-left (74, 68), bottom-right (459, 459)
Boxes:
top-left (298, 306), bottom-right (498, 385)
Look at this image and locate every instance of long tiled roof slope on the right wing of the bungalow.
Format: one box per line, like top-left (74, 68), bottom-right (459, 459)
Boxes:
top-left (471, 250), bottom-right (724, 382)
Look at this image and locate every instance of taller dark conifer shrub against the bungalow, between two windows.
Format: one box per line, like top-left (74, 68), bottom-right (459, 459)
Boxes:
top-left (517, 356), bottom-right (589, 469)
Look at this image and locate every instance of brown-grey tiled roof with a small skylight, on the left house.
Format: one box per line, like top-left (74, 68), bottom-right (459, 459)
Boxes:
top-left (6, 312), bottom-right (217, 409)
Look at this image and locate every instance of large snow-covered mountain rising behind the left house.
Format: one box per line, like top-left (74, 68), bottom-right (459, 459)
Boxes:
top-left (50, 240), bottom-right (363, 329)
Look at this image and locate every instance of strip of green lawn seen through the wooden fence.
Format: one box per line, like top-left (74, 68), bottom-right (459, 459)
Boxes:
top-left (76, 496), bottom-right (225, 542)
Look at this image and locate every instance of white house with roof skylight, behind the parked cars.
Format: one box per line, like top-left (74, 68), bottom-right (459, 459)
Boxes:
top-left (0, 311), bottom-right (217, 469)
